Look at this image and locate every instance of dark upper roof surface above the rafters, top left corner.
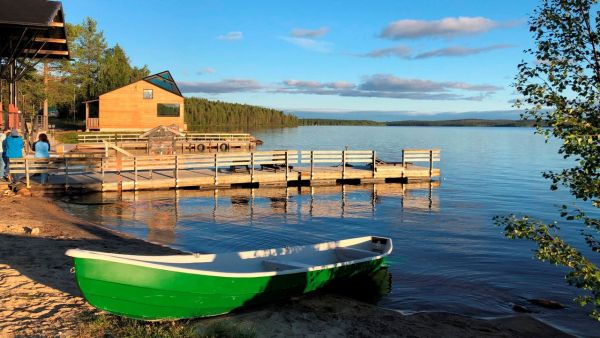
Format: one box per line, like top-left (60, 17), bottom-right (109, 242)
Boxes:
top-left (0, 0), bottom-right (62, 27)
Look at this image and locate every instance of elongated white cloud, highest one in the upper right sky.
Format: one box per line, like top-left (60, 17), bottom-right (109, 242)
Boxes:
top-left (379, 17), bottom-right (501, 40)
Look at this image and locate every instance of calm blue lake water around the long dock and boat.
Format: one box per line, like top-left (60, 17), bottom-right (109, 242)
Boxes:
top-left (65, 127), bottom-right (600, 336)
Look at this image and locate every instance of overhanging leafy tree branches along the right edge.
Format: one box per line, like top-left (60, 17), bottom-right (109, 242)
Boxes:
top-left (495, 0), bottom-right (600, 320)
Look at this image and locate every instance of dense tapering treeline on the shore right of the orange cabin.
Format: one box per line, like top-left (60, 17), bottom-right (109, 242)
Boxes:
top-left (184, 97), bottom-right (299, 130)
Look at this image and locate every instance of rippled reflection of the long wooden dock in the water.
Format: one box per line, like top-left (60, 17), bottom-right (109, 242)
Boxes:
top-left (64, 182), bottom-right (440, 250)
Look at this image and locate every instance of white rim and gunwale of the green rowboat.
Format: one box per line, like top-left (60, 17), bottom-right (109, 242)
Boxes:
top-left (65, 236), bottom-right (393, 278)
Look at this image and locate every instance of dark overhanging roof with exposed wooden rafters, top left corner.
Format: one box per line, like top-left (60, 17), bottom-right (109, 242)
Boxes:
top-left (0, 0), bottom-right (70, 59)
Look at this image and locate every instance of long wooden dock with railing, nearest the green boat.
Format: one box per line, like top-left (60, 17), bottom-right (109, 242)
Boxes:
top-left (10, 149), bottom-right (440, 191)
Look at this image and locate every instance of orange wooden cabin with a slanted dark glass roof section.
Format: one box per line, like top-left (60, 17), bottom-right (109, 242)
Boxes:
top-left (85, 71), bottom-right (187, 131)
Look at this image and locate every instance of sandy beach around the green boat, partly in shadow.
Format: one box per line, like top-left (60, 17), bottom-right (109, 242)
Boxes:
top-left (0, 193), bottom-right (568, 337)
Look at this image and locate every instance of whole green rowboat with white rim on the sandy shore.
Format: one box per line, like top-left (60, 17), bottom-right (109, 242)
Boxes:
top-left (66, 236), bottom-right (392, 320)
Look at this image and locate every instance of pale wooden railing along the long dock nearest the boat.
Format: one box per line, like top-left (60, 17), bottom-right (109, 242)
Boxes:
top-left (10, 149), bottom-right (440, 188)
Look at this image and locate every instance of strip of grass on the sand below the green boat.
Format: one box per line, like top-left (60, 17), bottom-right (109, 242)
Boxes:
top-left (77, 312), bottom-right (256, 338)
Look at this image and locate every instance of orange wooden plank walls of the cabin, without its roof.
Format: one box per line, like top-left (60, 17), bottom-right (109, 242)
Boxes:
top-left (99, 80), bottom-right (187, 131)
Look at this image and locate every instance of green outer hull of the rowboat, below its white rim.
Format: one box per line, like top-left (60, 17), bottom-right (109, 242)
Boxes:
top-left (74, 257), bottom-right (383, 320)
